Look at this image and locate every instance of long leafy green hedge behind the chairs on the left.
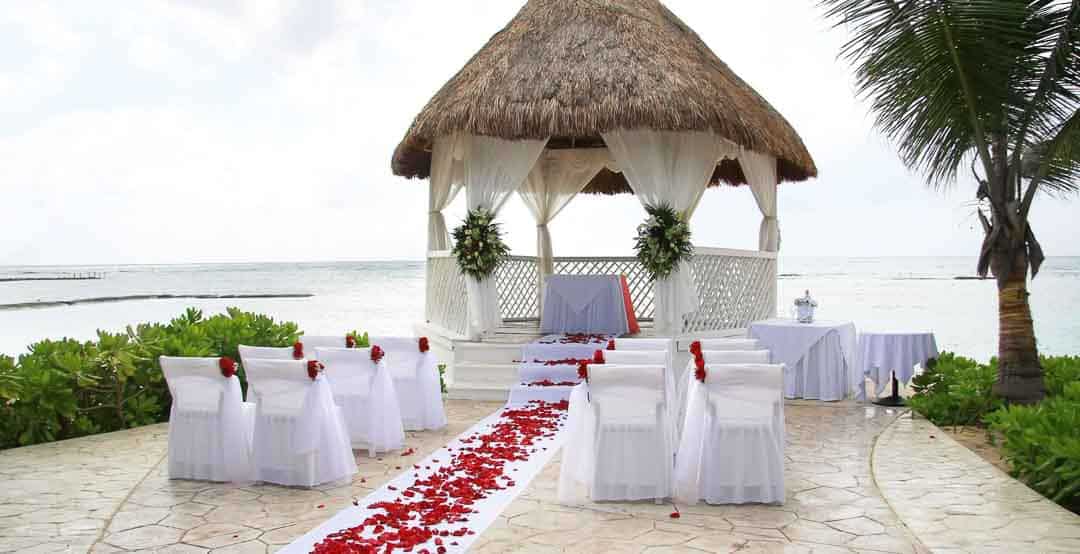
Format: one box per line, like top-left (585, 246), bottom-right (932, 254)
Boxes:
top-left (0, 308), bottom-right (300, 448)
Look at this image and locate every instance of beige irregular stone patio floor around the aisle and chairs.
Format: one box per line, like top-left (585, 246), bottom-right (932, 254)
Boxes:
top-left (0, 401), bottom-right (1080, 553)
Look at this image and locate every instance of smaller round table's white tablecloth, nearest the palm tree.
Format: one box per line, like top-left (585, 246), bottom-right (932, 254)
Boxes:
top-left (859, 333), bottom-right (937, 396)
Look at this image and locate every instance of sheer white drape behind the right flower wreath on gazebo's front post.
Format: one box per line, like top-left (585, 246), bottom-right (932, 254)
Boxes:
top-left (604, 130), bottom-right (731, 335)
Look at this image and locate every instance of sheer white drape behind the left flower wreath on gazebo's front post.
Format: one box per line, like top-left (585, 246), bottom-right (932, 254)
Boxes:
top-left (460, 135), bottom-right (548, 339)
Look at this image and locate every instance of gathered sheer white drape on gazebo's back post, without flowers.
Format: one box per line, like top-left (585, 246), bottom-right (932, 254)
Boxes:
top-left (517, 148), bottom-right (610, 315)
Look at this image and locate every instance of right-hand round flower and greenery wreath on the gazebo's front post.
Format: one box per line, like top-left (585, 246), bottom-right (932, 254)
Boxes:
top-left (634, 204), bottom-right (693, 281)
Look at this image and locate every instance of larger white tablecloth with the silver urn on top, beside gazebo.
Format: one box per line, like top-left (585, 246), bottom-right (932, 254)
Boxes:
top-left (750, 320), bottom-right (862, 401)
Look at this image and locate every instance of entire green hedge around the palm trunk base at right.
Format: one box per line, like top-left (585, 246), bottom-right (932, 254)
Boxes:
top-left (910, 353), bottom-right (1080, 512)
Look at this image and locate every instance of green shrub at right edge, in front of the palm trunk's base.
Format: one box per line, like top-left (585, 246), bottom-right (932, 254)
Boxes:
top-left (986, 380), bottom-right (1080, 512)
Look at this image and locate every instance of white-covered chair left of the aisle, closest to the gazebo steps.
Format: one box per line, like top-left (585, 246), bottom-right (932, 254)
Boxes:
top-left (368, 337), bottom-right (446, 431)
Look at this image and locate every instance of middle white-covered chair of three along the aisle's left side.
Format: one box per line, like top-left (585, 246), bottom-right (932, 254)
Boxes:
top-left (315, 347), bottom-right (405, 458)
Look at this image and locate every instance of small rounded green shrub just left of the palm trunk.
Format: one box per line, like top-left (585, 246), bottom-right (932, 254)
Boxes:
top-left (909, 352), bottom-right (1002, 425)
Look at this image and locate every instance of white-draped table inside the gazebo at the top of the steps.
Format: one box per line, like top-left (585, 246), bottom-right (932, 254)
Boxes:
top-left (540, 275), bottom-right (630, 335)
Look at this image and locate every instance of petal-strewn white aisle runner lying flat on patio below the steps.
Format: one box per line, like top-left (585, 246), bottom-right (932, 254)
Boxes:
top-left (280, 402), bottom-right (566, 554)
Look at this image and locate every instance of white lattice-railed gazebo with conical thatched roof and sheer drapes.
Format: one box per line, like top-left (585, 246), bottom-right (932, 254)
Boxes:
top-left (392, 0), bottom-right (818, 340)
